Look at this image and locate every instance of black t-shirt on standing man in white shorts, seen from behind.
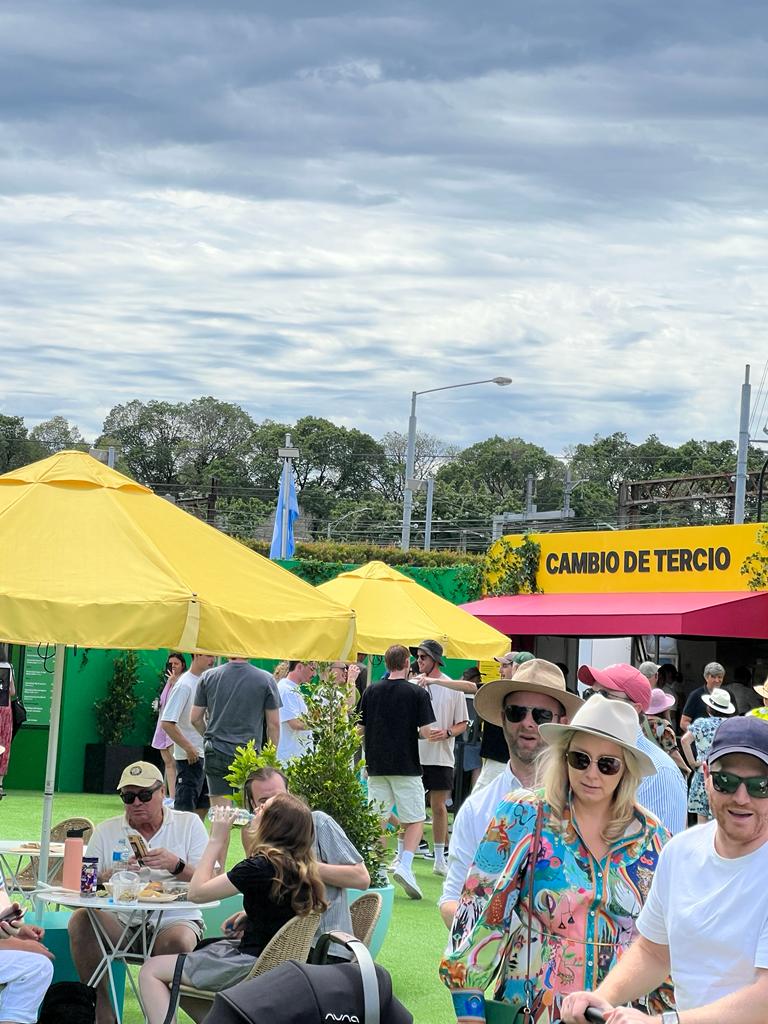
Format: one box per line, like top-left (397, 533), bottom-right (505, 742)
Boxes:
top-left (360, 679), bottom-right (435, 775)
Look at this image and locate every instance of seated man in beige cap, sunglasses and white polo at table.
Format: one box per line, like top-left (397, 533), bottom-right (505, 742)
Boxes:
top-left (69, 761), bottom-right (208, 1024)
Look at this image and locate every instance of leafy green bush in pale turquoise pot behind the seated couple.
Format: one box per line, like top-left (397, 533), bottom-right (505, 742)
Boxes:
top-left (226, 666), bottom-right (394, 954)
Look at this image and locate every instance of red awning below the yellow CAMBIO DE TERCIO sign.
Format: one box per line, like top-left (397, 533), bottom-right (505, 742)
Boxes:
top-left (462, 591), bottom-right (768, 640)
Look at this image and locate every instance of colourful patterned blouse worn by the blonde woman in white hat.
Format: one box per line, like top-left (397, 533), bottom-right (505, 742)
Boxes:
top-left (440, 790), bottom-right (671, 1024)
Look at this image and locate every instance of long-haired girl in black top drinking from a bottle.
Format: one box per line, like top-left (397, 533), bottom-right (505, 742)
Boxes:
top-left (139, 793), bottom-right (327, 1024)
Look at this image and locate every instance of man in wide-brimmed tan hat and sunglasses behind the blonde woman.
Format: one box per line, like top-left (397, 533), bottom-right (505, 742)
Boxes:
top-left (438, 658), bottom-right (584, 928)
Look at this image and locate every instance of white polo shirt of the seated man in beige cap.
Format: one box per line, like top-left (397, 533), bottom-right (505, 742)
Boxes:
top-left (88, 806), bottom-right (208, 927)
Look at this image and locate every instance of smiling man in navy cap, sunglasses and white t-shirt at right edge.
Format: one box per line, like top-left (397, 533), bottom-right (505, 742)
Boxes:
top-left (562, 717), bottom-right (768, 1024)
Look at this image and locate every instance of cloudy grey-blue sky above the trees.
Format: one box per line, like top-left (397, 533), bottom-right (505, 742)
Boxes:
top-left (0, 0), bottom-right (768, 453)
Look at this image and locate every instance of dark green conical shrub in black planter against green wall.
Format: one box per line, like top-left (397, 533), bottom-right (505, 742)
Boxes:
top-left (83, 650), bottom-right (143, 793)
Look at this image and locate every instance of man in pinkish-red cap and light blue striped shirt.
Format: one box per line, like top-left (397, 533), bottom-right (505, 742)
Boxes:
top-left (579, 664), bottom-right (688, 836)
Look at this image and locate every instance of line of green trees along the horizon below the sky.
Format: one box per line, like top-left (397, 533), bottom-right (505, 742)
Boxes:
top-left (0, 396), bottom-right (764, 547)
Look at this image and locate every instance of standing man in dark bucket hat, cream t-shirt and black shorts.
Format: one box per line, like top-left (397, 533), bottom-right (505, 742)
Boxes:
top-left (416, 640), bottom-right (469, 876)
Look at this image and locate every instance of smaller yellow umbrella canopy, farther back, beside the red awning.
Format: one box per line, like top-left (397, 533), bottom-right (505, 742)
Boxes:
top-left (317, 562), bottom-right (509, 660)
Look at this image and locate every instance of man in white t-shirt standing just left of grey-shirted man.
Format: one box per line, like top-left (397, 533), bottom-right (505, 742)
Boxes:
top-left (160, 654), bottom-right (214, 818)
